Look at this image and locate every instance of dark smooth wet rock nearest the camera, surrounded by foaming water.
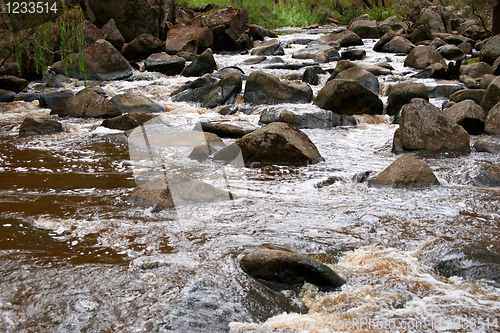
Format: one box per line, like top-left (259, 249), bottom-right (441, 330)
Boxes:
top-left (241, 249), bottom-right (345, 291)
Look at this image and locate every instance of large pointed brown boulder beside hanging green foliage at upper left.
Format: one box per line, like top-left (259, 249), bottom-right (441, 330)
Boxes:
top-left (53, 39), bottom-right (133, 81)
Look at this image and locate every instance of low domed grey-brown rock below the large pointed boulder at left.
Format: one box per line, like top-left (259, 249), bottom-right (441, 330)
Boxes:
top-left (50, 91), bottom-right (121, 118)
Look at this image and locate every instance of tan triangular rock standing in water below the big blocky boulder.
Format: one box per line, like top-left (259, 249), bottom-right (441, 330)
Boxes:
top-left (368, 154), bottom-right (439, 187)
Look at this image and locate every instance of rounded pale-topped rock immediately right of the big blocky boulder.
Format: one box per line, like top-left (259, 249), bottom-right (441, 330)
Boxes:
top-left (444, 99), bottom-right (486, 135)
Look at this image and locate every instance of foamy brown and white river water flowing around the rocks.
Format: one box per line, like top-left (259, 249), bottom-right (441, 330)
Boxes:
top-left (0, 30), bottom-right (500, 332)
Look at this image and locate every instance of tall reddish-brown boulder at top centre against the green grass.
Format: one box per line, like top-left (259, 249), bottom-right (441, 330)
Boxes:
top-left (194, 7), bottom-right (252, 52)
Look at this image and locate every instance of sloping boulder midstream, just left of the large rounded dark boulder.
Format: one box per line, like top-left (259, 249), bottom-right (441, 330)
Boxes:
top-left (243, 71), bottom-right (313, 104)
